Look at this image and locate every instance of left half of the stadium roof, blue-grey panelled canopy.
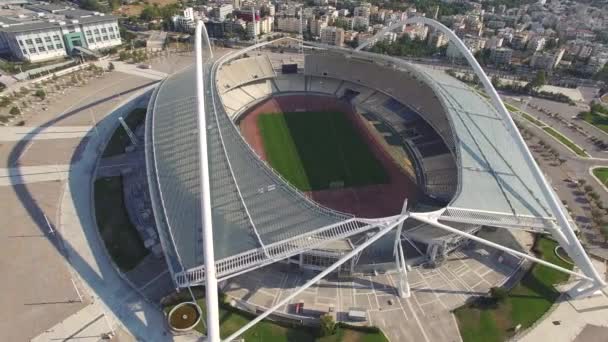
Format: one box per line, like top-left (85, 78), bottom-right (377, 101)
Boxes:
top-left (146, 48), bottom-right (386, 286)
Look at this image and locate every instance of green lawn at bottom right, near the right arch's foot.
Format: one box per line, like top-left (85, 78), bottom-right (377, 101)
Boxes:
top-left (454, 237), bottom-right (572, 342)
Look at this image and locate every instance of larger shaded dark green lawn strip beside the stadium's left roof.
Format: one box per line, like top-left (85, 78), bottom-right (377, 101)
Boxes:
top-left (94, 176), bottom-right (148, 271)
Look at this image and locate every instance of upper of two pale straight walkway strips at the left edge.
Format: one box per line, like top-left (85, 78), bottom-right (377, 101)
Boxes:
top-left (0, 126), bottom-right (92, 141)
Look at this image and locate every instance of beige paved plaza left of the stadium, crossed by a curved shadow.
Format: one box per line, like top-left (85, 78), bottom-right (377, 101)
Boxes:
top-left (0, 67), bottom-right (162, 341)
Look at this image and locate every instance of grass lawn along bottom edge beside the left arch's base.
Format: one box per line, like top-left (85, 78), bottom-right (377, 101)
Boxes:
top-left (164, 299), bottom-right (388, 342)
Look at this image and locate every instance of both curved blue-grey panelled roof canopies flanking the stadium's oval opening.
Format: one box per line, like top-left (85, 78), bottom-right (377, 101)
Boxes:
top-left (146, 31), bottom-right (600, 286)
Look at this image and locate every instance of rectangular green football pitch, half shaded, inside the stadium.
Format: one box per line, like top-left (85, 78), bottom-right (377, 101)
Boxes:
top-left (258, 112), bottom-right (388, 191)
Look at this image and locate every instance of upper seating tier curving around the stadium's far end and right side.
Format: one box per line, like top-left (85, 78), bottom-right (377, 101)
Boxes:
top-left (218, 55), bottom-right (458, 200)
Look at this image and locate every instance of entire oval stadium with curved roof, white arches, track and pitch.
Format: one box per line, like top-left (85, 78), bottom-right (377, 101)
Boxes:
top-left (145, 18), bottom-right (603, 342)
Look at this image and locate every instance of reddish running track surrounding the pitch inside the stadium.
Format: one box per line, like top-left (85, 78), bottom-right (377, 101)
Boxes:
top-left (240, 95), bottom-right (419, 218)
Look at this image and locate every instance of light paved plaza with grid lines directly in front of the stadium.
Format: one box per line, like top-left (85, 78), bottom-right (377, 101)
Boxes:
top-left (223, 247), bottom-right (516, 341)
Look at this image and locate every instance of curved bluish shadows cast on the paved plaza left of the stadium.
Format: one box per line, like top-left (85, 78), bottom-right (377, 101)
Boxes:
top-left (7, 81), bottom-right (167, 338)
